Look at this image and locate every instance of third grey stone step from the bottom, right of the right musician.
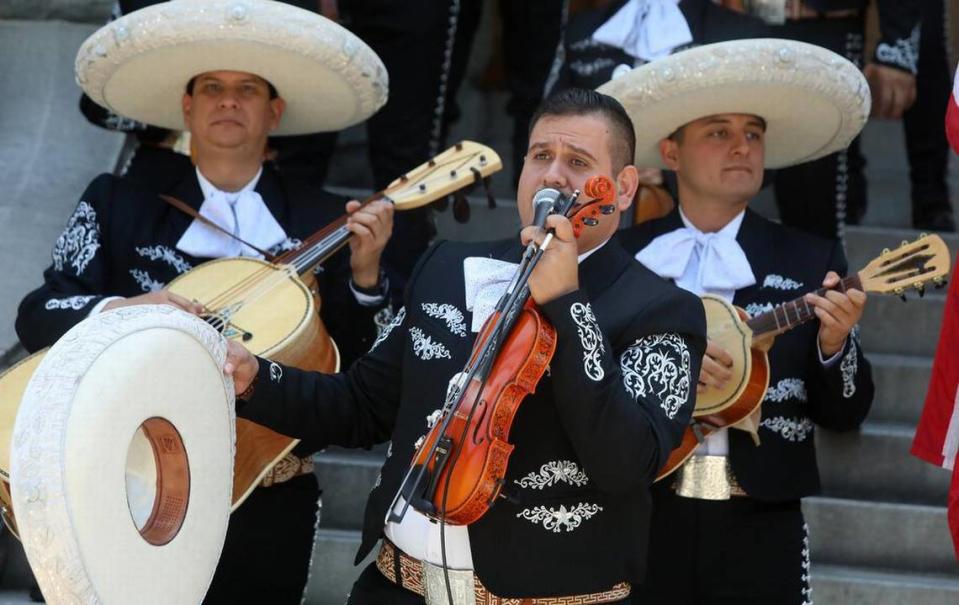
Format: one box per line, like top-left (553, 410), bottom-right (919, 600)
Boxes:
top-left (816, 422), bottom-right (950, 506)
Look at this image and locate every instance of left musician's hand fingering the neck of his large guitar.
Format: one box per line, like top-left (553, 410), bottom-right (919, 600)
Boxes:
top-left (346, 200), bottom-right (393, 288)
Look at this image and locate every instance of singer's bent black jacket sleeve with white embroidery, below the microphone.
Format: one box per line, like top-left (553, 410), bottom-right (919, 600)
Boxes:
top-left (542, 290), bottom-right (706, 492)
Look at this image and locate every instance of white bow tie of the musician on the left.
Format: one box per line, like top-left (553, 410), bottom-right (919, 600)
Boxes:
top-left (176, 189), bottom-right (286, 258)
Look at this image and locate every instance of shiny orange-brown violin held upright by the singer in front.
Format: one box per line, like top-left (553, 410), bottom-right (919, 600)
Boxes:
top-left (386, 176), bottom-right (615, 525)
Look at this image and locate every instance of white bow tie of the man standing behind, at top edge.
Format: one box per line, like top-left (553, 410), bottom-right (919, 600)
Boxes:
top-left (593, 0), bottom-right (693, 61)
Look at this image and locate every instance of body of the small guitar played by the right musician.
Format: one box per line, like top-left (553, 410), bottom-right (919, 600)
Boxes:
top-left (656, 294), bottom-right (769, 481)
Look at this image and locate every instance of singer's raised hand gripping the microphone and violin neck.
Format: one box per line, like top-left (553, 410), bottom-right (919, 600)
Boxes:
top-left (520, 214), bottom-right (579, 305)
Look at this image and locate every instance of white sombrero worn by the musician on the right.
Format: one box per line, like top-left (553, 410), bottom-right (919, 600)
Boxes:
top-left (598, 39), bottom-right (870, 168)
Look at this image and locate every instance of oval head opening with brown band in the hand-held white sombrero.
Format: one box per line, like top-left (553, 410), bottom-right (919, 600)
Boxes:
top-left (126, 416), bottom-right (190, 546)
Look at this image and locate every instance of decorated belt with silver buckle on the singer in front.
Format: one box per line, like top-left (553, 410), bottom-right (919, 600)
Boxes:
top-left (376, 538), bottom-right (631, 605)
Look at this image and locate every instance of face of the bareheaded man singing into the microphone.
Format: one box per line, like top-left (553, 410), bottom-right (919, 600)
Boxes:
top-left (516, 114), bottom-right (636, 252)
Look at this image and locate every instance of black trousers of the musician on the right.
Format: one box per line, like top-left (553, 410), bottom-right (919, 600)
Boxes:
top-left (633, 482), bottom-right (812, 605)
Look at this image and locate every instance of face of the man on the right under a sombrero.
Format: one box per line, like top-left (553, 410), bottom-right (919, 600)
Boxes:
top-left (660, 113), bottom-right (766, 203)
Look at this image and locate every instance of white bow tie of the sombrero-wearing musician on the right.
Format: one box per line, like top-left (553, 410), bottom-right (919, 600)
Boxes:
top-left (636, 227), bottom-right (756, 298)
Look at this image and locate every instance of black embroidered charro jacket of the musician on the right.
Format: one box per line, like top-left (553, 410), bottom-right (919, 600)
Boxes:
top-left (620, 210), bottom-right (874, 501)
